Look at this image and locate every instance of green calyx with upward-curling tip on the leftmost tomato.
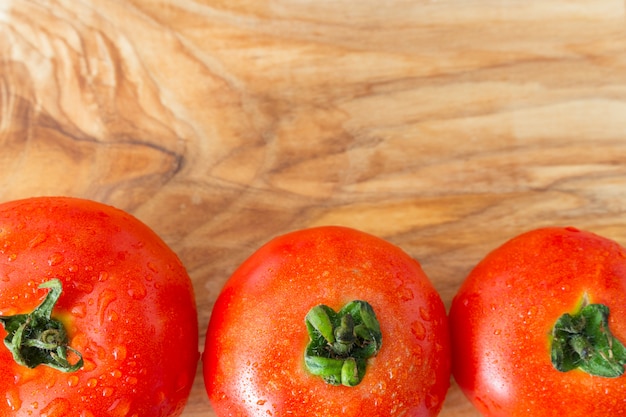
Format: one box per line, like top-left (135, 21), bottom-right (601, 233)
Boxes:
top-left (0, 278), bottom-right (83, 372)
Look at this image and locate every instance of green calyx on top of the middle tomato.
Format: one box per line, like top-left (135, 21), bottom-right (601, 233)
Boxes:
top-left (304, 300), bottom-right (382, 387)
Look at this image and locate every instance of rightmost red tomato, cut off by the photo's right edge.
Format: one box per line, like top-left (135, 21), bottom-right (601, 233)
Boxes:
top-left (449, 227), bottom-right (626, 417)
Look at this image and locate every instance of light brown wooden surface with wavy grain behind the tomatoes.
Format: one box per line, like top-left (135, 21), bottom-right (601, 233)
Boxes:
top-left (0, 0), bottom-right (626, 417)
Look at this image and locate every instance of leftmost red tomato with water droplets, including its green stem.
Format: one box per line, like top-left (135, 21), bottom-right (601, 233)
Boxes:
top-left (0, 197), bottom-right (199, 417)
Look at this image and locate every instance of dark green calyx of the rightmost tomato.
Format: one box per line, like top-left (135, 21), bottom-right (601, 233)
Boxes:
top-left (551, 297), bottom-right (626, 378)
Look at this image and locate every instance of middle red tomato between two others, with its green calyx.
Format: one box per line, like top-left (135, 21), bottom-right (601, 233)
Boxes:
top-left (203, 226), bottom-right (450, 417)
